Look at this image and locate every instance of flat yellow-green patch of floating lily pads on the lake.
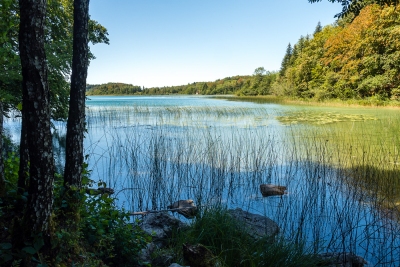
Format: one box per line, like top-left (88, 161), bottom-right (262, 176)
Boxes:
top-left (277, 111), bottom-right (377, 125)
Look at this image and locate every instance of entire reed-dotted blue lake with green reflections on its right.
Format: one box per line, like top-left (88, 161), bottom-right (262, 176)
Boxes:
top-left (6, 96), bottom-right (400, 266)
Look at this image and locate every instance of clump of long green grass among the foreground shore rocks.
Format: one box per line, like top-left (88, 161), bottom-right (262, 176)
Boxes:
top-left (170, 207), bottom-right (318, 267)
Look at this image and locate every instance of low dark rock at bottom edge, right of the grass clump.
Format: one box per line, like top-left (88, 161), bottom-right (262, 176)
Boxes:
top-left (319, 252), bottom-right (368, 267)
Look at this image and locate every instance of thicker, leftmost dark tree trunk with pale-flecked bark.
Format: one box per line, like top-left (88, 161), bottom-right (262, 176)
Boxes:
top-left (14, 0), bottom-right (54, 262)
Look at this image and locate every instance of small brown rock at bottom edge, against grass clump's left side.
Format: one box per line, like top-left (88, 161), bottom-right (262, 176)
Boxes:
top-left (182, 243), bottom-right (216, 267)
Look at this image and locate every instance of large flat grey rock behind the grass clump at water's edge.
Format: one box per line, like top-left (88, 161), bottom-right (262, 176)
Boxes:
top-left (228, 208), bottom-right (279, 239)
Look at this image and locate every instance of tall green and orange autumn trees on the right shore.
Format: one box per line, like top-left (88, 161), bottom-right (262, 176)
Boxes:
top-left (273, 4), bottom-right (400, 101)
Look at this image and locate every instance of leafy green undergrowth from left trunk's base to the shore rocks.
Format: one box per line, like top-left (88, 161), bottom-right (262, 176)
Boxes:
top-left (50, 177), bottom-right (150, 266)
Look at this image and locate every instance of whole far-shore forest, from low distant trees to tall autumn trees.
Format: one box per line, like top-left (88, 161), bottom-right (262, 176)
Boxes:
top-left (87, 4), bottom-right (400, 101)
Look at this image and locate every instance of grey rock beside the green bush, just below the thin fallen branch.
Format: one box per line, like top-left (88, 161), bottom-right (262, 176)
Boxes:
top-left (140, 212), bottom-right (187, 247)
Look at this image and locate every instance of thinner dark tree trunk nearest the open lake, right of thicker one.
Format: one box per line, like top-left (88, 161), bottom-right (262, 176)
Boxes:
top-left (64, 0), bottom-right (89, 188)
